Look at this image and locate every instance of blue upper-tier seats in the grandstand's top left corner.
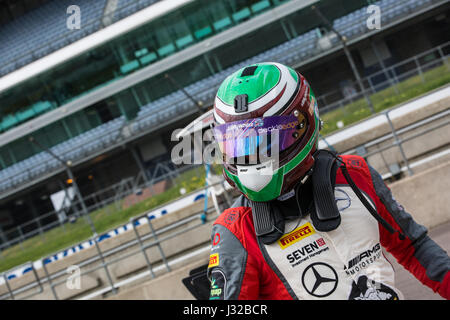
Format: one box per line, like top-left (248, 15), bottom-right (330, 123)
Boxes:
top-left (0, 0), bottom-right (166, 76)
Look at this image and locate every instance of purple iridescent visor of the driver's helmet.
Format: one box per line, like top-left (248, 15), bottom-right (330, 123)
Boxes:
top-left (214, 113), bottom-right (306, 163)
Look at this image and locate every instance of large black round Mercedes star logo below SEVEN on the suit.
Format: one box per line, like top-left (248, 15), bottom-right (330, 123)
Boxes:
top-left (302, 262), bottom-right (338, 298)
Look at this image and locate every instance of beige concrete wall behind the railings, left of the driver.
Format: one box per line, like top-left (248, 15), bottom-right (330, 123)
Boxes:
top-left (0, 199), bottom-right (216, 300)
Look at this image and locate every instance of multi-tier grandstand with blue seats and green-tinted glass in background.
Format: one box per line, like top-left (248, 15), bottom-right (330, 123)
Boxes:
top-left (0, 0), bottom-right (450, 268)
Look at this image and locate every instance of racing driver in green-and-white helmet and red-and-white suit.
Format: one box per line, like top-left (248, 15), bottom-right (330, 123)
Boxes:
top-left (207, 63), bottom-right (450, 300)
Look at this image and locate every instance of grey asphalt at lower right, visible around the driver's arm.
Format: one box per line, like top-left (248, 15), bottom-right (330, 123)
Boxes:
top-left (386, 222), bottom-right (450, 300)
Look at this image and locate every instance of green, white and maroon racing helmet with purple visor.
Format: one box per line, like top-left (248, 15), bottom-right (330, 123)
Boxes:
top-left (214, 62), bottom-right (320, 202)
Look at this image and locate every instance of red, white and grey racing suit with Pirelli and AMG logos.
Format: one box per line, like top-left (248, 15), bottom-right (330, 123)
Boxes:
top-left (207, 156), bottom-right (450, 300)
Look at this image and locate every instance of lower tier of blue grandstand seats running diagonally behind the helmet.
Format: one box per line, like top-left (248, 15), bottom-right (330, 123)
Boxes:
top-left (0, 0), bottom-right (440, 192)
